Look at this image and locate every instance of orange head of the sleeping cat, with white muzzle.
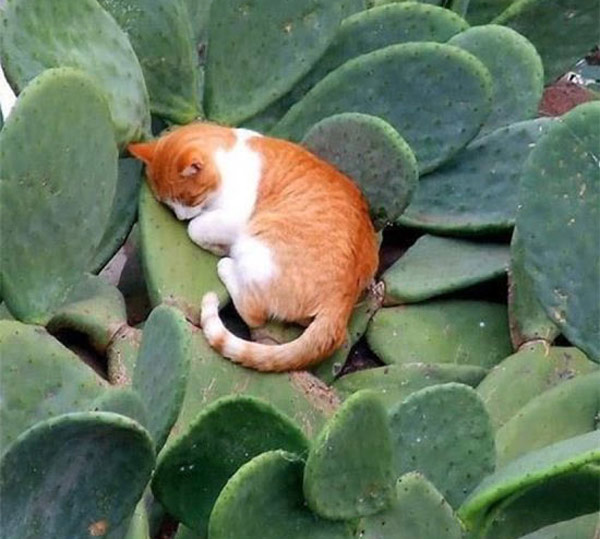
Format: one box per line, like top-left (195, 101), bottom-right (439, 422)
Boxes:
top-left (127, 123), bottom-right (234, 220)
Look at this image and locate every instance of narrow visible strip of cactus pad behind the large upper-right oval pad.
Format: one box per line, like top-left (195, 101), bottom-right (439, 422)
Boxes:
top-left (248, 2), bottom-right (468, 131)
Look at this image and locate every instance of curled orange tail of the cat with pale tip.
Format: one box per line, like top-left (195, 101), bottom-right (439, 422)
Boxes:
top-left (201, 292), bottom-right (352, 372)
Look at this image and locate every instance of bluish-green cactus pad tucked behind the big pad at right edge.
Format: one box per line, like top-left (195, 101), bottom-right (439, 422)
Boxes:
top-left (398, 118), bottom-right (552, 234)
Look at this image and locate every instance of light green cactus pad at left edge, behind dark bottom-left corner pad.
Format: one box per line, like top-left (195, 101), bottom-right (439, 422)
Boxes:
top-left (0, 320), bottom-right (107, 453)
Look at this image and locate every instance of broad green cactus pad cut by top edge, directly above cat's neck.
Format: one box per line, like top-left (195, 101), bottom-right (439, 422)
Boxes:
top-left (205, 0), bottom-right (343, 124)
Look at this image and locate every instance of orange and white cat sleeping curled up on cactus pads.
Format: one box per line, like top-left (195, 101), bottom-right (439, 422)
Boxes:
top-left (129, 123), bottom-right (378, 371)
